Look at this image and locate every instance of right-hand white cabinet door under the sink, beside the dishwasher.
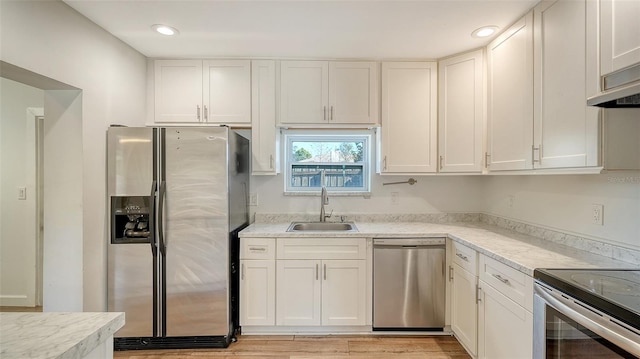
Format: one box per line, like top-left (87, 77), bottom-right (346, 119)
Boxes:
top-left (322, 260), bottom-right (367, 325)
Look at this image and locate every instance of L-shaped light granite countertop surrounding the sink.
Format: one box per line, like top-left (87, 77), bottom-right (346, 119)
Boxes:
top-left (240, 222), bottom-right (635, 276)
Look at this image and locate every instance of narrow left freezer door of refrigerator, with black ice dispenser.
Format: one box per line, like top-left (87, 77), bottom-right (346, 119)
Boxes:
top-left (107, 127), bottom-right (157, 337)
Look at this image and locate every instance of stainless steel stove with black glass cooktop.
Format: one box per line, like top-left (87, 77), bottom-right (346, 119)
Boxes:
top-left (533, 269), bottom-right (640, 359)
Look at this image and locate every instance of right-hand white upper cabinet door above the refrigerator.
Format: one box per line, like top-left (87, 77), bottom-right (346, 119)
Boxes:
top-left (203, 60), bottom-right (251, 125)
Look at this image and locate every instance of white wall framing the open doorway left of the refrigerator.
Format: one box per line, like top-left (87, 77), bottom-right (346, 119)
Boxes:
top-left (0, 1), bottom-right (146, 311)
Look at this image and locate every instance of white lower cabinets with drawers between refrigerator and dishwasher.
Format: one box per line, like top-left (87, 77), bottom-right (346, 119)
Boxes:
top-left (240, 238), bottom-right (372, 333)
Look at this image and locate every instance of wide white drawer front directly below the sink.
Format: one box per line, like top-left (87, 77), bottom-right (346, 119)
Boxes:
top-left (277, 238), bottom-right (367, 259)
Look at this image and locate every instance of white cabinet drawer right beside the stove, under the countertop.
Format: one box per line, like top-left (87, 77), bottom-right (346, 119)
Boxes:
top-left (479, 255), bottom-right (533, 312)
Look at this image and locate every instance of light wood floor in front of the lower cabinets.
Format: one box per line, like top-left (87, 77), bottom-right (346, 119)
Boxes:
top-left (113, 335), bottom-right (471, 359)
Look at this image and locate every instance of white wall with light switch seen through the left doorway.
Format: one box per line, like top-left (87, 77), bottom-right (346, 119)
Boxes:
top-left (0, 78), bottom-right (44, 306)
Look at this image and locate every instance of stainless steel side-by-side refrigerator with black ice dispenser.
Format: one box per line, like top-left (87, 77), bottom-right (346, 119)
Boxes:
top-left (107, 127), bottom-right (249, 350)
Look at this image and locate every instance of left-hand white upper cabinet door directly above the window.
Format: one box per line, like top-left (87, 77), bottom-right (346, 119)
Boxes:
top-left (280, 61), bottom-right (329, 124)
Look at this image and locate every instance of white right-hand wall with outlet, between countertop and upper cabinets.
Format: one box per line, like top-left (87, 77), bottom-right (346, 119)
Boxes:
top-left (480, 172), bottom-right (640, 249)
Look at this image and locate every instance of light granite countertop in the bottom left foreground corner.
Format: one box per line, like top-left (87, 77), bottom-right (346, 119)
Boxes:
top-left (0, 313), bottom-right (124, 359)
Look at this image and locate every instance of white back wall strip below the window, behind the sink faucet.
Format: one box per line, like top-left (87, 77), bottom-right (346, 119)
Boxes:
top-left (251, 174), bottom-right (482, 215)
